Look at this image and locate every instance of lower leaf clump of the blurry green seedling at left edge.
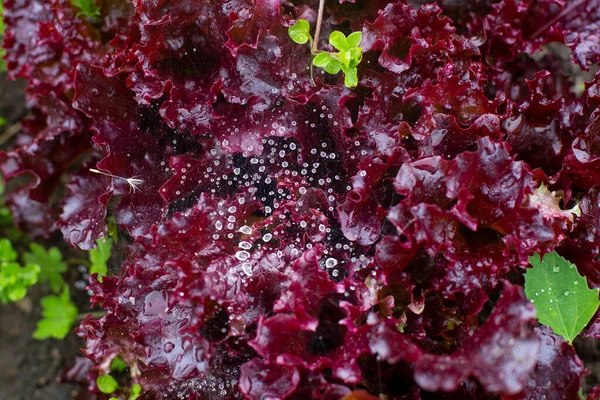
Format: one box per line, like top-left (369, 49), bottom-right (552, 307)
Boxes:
top-left (0, 262), bottom-right (40, 303)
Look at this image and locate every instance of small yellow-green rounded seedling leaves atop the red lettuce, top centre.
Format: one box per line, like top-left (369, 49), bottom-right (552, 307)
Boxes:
top-left (288, 19), bottom-right (362, 87)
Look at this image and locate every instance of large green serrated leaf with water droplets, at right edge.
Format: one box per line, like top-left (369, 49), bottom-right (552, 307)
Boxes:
top-left (525, 252), bottom-right (600, 343)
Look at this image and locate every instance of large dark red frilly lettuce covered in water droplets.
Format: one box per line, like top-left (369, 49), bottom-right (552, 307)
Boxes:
top-left (0, 0), bottom-right (600, 400)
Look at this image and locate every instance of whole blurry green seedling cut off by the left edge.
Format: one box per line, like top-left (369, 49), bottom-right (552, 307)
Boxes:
top-left (0, 239), bottom-right (40, 303)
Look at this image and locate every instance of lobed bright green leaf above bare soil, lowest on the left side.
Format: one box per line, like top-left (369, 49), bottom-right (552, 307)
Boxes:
top-left (33, 286), bottom-right (78, 339)
